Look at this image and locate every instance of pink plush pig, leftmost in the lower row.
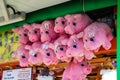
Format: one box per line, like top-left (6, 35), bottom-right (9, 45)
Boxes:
top-left (12, 45), bottom-right (29, 67)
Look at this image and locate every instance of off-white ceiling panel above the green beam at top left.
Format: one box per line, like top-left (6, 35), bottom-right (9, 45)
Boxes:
top-left (0, 0), bottom-right (70, 16)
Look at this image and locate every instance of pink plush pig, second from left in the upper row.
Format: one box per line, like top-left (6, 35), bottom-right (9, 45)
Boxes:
top-left (23, 23), bottom-right (41, 42)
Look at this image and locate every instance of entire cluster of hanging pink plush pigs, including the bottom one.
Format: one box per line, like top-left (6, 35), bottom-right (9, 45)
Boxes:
top-left (13, 14), bottom-right (113, 80)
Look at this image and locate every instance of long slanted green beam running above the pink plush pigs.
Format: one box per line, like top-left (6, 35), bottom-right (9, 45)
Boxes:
top-left (0, 0), bottom-right (117, 31)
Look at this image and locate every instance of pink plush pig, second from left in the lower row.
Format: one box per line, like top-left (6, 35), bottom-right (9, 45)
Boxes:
top-left (25, 42), bottom-right (43, 65)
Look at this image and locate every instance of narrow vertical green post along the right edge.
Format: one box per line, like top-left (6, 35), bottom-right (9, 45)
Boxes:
top-left (117, 0), bottom-right (120, 80)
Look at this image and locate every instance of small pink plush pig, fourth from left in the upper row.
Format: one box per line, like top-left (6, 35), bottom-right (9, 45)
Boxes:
top-left (54, 17), bottom-right (66, 34)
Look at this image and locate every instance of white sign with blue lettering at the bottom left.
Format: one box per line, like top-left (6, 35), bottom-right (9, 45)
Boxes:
top-left (2, 68), bottom-right (32, 80)
